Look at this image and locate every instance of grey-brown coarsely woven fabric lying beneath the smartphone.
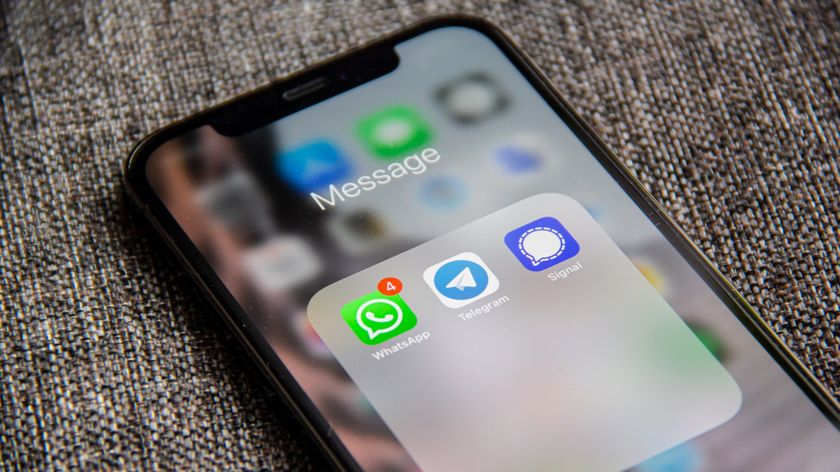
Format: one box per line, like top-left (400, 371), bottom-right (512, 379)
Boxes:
top-left (0, 0), bottom-right (840, 469)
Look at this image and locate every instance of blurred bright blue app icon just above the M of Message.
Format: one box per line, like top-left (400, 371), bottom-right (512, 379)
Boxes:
top-left (277, 140), bottom-right (351, 192)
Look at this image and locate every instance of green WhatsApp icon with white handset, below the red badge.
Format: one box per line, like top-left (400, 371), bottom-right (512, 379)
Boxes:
top-left (341, 292), bottom-right (417, 346)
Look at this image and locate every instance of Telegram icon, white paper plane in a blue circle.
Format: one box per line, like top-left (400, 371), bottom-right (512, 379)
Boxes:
top-left (423, 252), bottom-right (499, 308)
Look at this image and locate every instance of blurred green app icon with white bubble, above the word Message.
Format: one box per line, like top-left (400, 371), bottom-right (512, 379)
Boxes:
top-left (357, 105), bottom-right (432, 159)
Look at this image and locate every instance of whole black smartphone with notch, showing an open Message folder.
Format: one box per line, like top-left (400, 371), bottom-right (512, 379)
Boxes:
top-left (125, 17), bottom-right (840, 471)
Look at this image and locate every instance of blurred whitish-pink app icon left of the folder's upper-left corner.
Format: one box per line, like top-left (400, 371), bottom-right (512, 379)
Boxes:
top-left (244, 236), bottom-right (321, 293)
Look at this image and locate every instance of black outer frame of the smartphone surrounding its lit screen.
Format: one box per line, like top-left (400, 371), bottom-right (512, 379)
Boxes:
top-left (123, 15), bottom-right (840, 470)
